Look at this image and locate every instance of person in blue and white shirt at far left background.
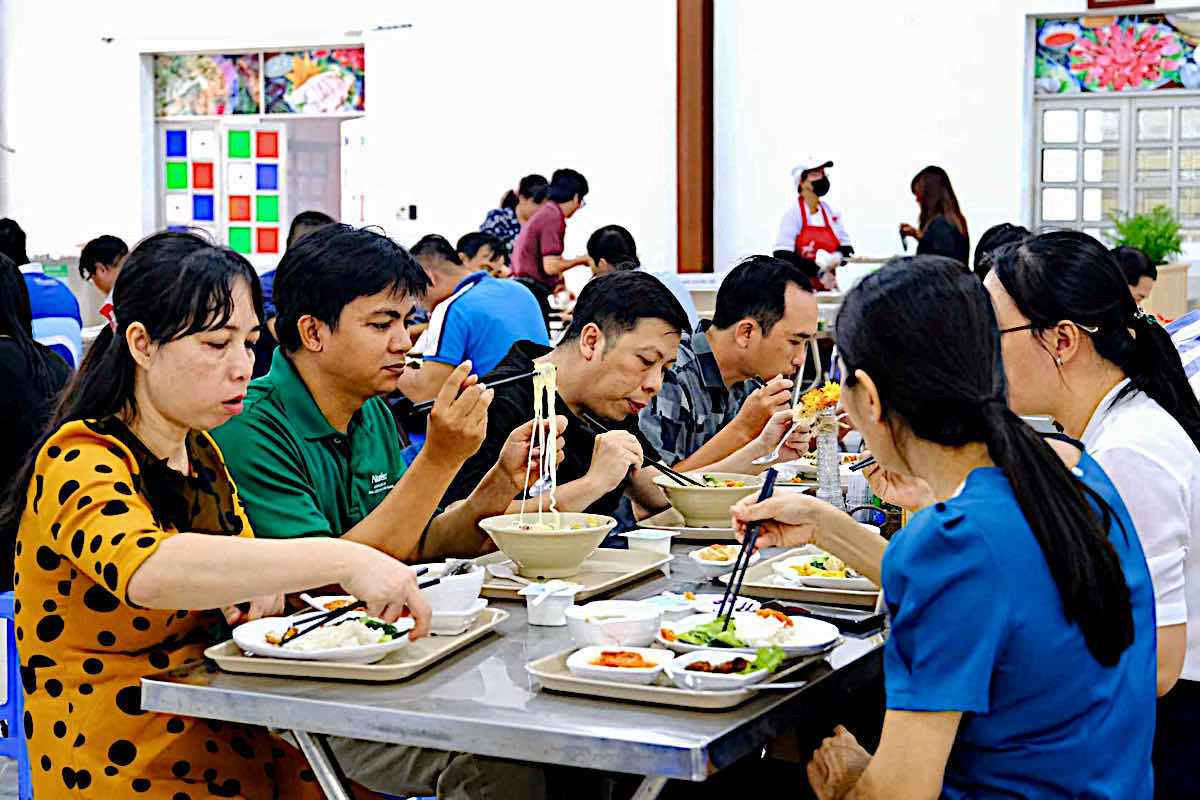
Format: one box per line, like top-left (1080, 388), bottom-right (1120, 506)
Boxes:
top-left (0, 217), bottom-right (83, 368)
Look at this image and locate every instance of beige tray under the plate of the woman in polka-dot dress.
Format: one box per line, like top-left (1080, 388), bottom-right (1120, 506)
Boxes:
top-left (204, 608), bottom-right (509, 682)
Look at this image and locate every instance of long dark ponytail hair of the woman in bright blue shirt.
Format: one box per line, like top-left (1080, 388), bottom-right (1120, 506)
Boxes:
top-left (838, 255), bottom-right (1134, 666)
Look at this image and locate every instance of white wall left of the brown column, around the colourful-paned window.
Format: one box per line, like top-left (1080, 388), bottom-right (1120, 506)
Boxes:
top-left (0, 0), bottom-right (676, 264)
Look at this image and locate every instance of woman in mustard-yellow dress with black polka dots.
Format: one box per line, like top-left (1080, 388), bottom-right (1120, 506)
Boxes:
top-left (4, 233), bottom-right (430, 799)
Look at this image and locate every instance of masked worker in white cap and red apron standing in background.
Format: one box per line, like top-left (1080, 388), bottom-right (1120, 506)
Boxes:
top-left (775, 157), bottom-right (854, 290)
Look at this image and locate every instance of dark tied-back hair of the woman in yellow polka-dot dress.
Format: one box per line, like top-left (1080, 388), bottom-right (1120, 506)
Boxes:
top-left (0, 233), bottom-right (263, 529)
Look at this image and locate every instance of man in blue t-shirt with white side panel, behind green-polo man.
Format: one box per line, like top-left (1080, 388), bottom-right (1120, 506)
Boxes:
top-left (400, 235), bottom-right (550, 403)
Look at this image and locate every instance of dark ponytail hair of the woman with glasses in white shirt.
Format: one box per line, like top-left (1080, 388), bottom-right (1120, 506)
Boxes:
top-left (992, 230), bottom-right (1200, 450)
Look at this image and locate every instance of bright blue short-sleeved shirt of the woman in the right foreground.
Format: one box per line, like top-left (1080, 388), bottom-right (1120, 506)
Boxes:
top-left (883, 455), bottom-right (1157, 800)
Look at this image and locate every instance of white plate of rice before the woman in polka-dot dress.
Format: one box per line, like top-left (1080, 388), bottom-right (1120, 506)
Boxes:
top-left (233, 613), bottom-right (415, 664)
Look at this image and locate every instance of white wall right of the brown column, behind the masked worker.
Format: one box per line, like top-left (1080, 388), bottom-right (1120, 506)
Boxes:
top-left (714, 0), bottom-right (1200, 269)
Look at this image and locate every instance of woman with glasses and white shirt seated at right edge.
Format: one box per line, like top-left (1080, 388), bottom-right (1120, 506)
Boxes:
top-left (984, 231), bottom-right (1200, 798)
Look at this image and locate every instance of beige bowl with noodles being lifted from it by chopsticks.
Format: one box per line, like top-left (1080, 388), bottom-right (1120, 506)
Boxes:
top-left (479, 511), bottom-right (617, 581)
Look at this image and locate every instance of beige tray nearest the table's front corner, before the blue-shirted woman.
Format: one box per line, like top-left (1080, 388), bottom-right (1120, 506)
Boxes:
top-left (526, 638), bottom-right (841, 711)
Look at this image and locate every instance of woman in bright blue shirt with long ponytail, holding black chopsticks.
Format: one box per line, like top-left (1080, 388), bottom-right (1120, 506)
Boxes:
top-left (734, 257), bottom-right (1156, 800)
